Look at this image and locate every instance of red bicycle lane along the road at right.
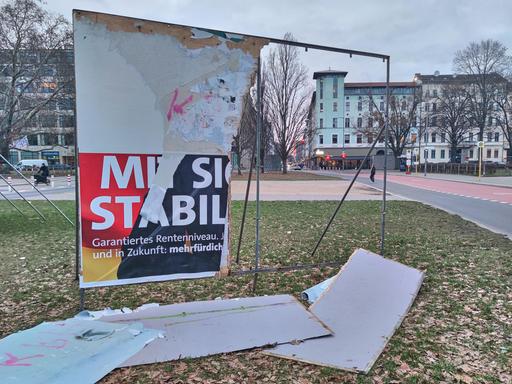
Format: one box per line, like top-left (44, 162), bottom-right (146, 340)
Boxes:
top-left (377, 174), bottom-right (512, 204)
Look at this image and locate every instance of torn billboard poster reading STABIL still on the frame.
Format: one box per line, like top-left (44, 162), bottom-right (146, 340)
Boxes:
top-left (73, 11), bottom-right (267, 288)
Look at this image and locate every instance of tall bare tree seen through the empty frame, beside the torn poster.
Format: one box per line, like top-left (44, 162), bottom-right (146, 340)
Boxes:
top-left (263, 33), bottom-right (310, 173)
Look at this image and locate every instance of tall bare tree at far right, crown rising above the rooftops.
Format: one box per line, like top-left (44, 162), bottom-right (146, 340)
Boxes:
top-left (453, 40), bottom-right (511, 146)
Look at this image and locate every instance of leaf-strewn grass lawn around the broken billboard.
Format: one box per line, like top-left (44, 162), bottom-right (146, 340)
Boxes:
top-left (0, 201), bottom-right (512, 383)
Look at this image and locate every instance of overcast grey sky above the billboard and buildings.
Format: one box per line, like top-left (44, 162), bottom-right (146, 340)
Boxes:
top-left (45, 0), bottom-right (512, 82)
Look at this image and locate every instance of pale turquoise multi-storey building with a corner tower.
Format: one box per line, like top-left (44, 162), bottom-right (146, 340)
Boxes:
top-left (308, 70), bottom-right (417, 168)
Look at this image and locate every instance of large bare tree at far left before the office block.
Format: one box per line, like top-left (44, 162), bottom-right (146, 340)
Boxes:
top-left (0, 0), bottom-right (72, 157)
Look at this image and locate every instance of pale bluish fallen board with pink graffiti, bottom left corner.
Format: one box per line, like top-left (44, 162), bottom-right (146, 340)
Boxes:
top-left (0, 319), bottom-right (160, 384)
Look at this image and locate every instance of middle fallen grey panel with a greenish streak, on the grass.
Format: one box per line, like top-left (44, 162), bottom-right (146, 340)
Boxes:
top-left (101, 295), bottom-right (332, 366)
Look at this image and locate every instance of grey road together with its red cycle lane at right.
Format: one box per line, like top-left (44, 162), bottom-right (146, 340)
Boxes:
top-left (316, 171), bottom-right (512, 239)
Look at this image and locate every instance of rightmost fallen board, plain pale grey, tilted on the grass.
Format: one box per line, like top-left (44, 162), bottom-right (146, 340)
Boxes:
top-left (265, 249), bottom-right (423, 373)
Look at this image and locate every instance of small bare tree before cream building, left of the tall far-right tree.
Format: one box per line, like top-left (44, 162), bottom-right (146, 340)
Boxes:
top-left (433, 84), bottom-right (471, 163)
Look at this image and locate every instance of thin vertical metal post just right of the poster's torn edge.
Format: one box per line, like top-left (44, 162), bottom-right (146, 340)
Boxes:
top-left (252, 58), bottom-right (262, 292)
